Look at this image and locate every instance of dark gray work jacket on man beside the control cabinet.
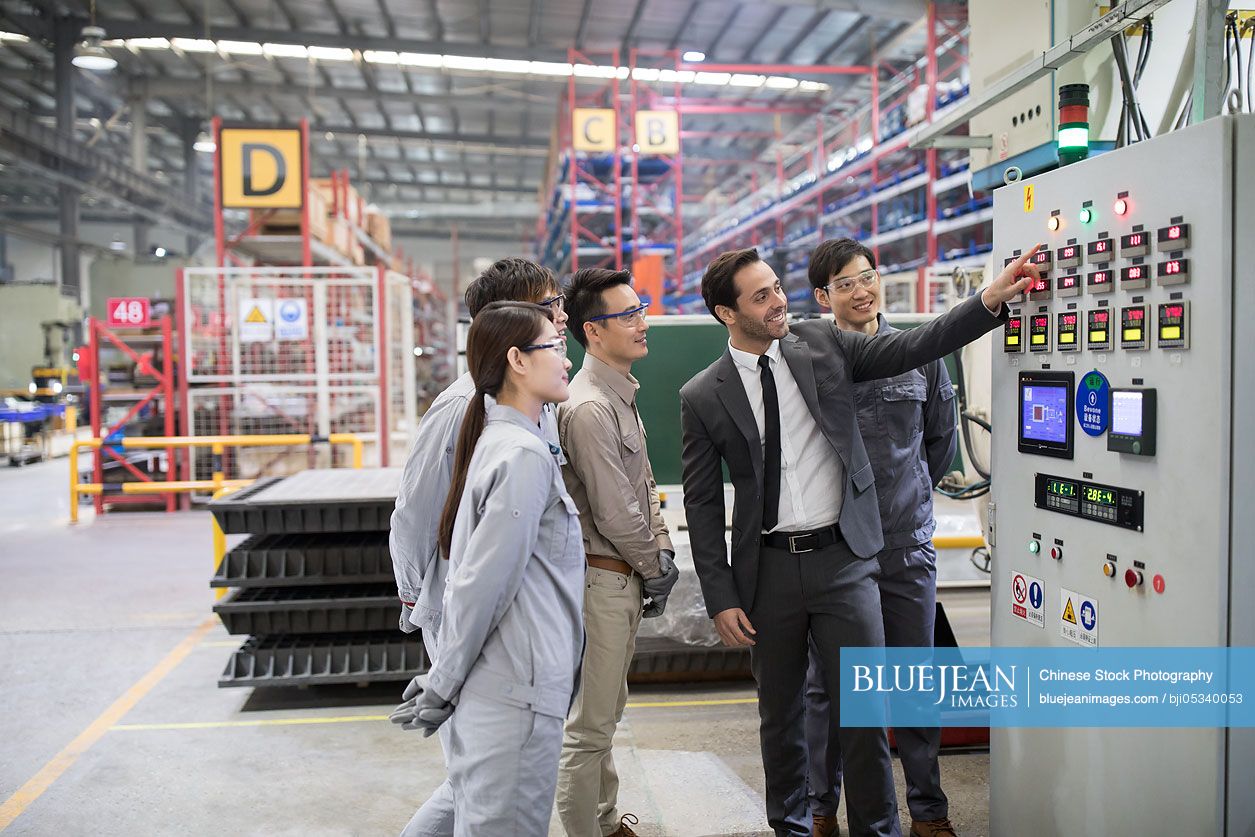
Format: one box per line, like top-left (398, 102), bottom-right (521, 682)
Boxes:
top-left (855, 315), bottom-right (958, 550)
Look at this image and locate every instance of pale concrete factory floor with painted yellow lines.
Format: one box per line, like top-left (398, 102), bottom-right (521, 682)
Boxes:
top-left (0, 459), bottom-right (989, 837)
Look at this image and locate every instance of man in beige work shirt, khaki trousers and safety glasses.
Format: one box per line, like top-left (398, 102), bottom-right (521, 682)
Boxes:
top-left (557, 269), bottom-right (679, 837)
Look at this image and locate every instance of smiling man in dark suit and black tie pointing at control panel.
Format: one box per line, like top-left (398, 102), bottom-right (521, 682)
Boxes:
top-left (680, 247), bottom-right (1037, 837)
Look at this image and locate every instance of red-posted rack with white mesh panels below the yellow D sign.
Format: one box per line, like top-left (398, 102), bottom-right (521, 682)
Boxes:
top-left (177, 119), bottom-right (453, 496)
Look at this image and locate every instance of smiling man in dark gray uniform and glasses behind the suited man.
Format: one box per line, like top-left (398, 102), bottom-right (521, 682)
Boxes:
top-left (806, 238), bottom-right (958, 837)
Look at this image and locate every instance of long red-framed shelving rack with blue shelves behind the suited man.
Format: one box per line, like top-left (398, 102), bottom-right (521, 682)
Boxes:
top-left (665, 4), bottom-right (991, 312)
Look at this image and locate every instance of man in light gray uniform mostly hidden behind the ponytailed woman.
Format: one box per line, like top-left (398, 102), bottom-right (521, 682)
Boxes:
top-left (388, 259), bottom-right (566, 837)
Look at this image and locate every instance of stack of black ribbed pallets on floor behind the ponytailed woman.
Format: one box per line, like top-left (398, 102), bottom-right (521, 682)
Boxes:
top-left (210, 468), bottom-right (428, 686)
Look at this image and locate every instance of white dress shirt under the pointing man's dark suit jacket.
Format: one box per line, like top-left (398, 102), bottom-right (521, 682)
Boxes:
top-left (728, 340), bottom-right (846, 532)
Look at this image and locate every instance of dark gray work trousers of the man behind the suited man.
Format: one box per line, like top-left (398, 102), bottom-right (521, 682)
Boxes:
top-left (806, 543), bottom-right (950, 819)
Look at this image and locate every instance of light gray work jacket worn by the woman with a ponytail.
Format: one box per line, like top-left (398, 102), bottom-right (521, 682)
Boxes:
top-left (428, 404), bottom-right (584, 718)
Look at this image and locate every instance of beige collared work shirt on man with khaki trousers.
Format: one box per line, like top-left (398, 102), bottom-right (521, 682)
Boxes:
top-left (558, 354), bottom-right (673, 578)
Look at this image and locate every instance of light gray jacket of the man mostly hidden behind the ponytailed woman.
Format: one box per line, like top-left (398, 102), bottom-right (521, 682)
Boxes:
top-left (388, 373), bottom-right (557, 637)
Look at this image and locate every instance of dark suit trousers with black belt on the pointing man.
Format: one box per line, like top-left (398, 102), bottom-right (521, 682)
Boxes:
top-left (748, 542), bottom-right (901, 837)
